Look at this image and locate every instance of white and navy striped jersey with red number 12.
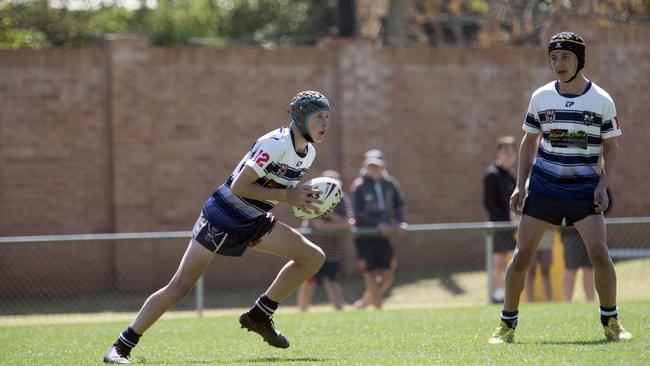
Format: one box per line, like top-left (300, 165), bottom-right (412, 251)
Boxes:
top-left (203, 127), bottom-right (316, 231)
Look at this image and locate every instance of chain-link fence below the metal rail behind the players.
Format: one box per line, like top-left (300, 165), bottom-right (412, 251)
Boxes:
top-left (0, 218), bottom-right (650, 319)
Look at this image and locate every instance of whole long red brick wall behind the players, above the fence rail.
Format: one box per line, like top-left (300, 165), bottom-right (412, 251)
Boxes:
top-left (0, 24), bottom-right (650, 294)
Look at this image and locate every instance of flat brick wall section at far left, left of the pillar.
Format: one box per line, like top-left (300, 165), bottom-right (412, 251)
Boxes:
top-left (0, 48), bottom-right (113, 235)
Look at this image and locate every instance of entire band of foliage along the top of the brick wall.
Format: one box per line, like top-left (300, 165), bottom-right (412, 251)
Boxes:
top-left (0, 0), bottom-right (650, 48)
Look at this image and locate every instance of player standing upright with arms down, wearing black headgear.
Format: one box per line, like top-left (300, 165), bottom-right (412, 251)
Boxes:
top-left (488, 32), bottom-right (632, 344)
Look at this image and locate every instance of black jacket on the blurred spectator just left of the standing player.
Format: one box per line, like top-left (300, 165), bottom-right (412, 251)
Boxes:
top-left (483, 164), bottom-right (517, 221)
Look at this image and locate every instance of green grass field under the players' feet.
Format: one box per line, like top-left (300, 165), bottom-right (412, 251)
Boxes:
top-left (0, 300), bottom-right (650, 365)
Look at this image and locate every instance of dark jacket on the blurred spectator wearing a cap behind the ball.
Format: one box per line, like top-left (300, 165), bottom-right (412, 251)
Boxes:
top-left (352, 175), bottom-right (406, 228)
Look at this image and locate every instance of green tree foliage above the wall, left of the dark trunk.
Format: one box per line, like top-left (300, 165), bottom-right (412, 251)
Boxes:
top-left (0, 0), bottom-right (336, 48)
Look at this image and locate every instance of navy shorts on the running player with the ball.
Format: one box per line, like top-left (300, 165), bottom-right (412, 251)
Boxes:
top-left (192, 212), bottom-right (277, 257)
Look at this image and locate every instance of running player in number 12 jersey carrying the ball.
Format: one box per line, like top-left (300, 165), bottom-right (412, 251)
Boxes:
top-left (104, 91), bottom-right (330, 364)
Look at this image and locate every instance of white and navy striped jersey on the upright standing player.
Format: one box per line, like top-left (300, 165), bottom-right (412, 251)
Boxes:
top-left (523, 81), bottom-right (621, 200)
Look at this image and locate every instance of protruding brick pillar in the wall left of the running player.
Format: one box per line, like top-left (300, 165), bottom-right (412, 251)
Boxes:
top-left (106, 36), bottom-right (155, 232)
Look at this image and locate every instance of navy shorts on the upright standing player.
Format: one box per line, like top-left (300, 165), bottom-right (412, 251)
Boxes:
top-left (523, 192), bottom-right (602, 226)
